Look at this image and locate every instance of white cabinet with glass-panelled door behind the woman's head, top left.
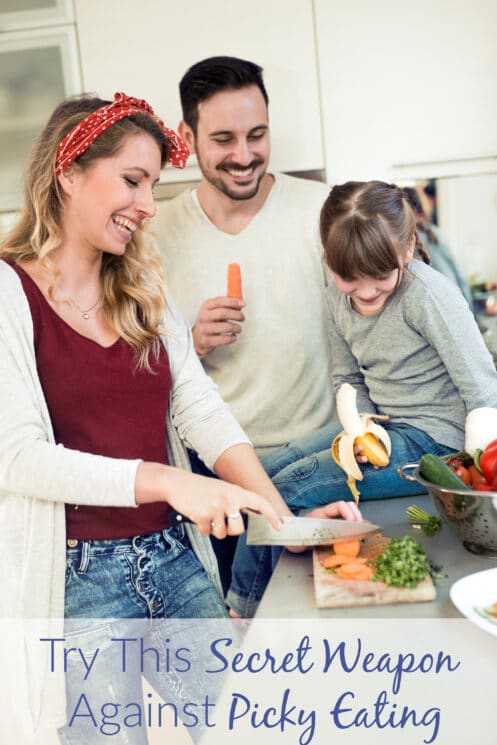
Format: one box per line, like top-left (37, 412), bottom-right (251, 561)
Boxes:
top-left (0, 0), bottom-right (81, 214)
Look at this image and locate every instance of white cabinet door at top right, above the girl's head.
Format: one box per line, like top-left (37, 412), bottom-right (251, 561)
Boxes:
top-left (314, 0), bottom-right (497, 183)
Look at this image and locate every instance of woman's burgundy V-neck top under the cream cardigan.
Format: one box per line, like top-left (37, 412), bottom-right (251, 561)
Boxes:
top-left (13, 265), bottom-right (171, 540)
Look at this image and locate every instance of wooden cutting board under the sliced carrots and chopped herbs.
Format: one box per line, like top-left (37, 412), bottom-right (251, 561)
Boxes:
top-left (313, 533), bottom-right (436, 608)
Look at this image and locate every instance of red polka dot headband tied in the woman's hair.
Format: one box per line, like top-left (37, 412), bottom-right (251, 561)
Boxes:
top-left (55, 93), bottom-right (190, 176)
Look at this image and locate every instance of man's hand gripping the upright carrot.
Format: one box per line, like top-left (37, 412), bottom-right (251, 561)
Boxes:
top-left (192, 296), bottom-right (245, 357)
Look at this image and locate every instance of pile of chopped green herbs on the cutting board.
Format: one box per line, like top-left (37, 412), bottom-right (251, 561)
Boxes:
top-left (372, 535), bottom-right (430, 589)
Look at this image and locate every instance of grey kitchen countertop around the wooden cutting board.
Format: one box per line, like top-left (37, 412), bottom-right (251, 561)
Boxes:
top-left (256, 494), bottom-right (497, 618)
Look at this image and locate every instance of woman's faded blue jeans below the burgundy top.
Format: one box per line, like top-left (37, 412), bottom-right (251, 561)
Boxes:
top-left (59, 526), bottom-right (232, 745)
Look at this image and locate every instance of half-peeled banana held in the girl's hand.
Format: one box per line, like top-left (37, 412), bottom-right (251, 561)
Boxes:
top-left (331, 383), bottom-right (392, 504)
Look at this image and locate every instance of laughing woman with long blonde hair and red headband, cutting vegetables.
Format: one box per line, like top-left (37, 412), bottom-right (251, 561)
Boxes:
top-left (0, 93), bottom-right (324, 742)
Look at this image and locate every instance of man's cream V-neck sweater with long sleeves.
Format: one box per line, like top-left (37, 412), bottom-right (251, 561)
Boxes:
top-left (154, 173), bottom-right (334, 455)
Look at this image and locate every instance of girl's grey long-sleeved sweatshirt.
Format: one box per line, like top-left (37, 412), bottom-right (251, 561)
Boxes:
top-left (328, 260), bottom-right (497, 449)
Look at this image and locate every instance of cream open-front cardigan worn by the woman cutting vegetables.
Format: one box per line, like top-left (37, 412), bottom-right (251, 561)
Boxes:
top-left (0, 260), bottom-right (248, 743)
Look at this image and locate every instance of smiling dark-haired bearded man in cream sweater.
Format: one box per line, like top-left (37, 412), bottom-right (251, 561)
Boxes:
top-left (161, 57), bottom-right (333, 456)
